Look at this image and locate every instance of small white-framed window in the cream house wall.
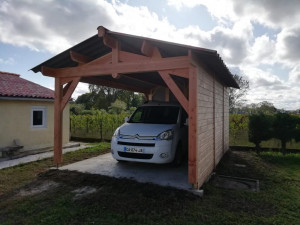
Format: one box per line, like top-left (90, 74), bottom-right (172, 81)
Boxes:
top-left (31, 106), bottom-right (47, 128)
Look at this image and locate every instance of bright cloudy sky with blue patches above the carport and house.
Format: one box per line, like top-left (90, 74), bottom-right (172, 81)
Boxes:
top-left (0, 0), bottom-right (300, 109)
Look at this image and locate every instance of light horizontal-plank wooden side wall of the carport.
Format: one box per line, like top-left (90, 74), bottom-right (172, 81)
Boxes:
top-left (196, 65), bottom-right (229, 187)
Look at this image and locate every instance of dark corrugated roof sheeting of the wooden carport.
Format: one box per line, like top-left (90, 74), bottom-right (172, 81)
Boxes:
top-left (31, 26), bottom-right (239, 88)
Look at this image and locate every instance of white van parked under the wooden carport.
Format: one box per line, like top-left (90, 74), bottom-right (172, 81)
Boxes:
top-left (111, 102), bottom-right (188, 166)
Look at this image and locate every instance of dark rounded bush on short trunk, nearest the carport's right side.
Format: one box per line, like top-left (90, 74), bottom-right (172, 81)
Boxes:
top-left (248, 114), bottom-right (272, 154)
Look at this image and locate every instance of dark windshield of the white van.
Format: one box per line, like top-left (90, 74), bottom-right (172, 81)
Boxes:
top-left (128, 106), bottom-right (179, 124)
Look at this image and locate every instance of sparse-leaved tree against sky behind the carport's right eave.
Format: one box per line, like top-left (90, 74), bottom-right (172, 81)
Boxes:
top-left (229, 74), bottom-right (249, 113)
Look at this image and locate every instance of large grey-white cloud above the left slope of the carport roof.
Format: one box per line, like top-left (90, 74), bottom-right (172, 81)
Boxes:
top-left (0, 0), bottom-right (117, 53)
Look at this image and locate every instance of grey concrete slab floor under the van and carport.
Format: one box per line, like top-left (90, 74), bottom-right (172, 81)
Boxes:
top-left (60, 153), bottom-right (192, 190)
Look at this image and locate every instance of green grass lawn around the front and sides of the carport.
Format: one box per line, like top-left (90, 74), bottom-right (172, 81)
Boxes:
top-left (0, 147), bottom-right (300, 225)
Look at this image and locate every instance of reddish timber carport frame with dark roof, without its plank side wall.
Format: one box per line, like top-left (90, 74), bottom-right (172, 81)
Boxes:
top-left (32, 26), bottom-right (238, 186)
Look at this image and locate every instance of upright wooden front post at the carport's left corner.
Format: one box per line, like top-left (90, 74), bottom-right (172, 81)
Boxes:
top-left (54, 78), bottom-right (63, 166)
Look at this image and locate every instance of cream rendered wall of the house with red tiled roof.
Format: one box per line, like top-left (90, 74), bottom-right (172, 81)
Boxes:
top-left (0, 100), bottom-right (70, 151)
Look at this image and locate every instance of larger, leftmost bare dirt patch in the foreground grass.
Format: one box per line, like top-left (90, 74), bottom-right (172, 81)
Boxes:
top-left (17, 180), bottom-right (59, 196)
